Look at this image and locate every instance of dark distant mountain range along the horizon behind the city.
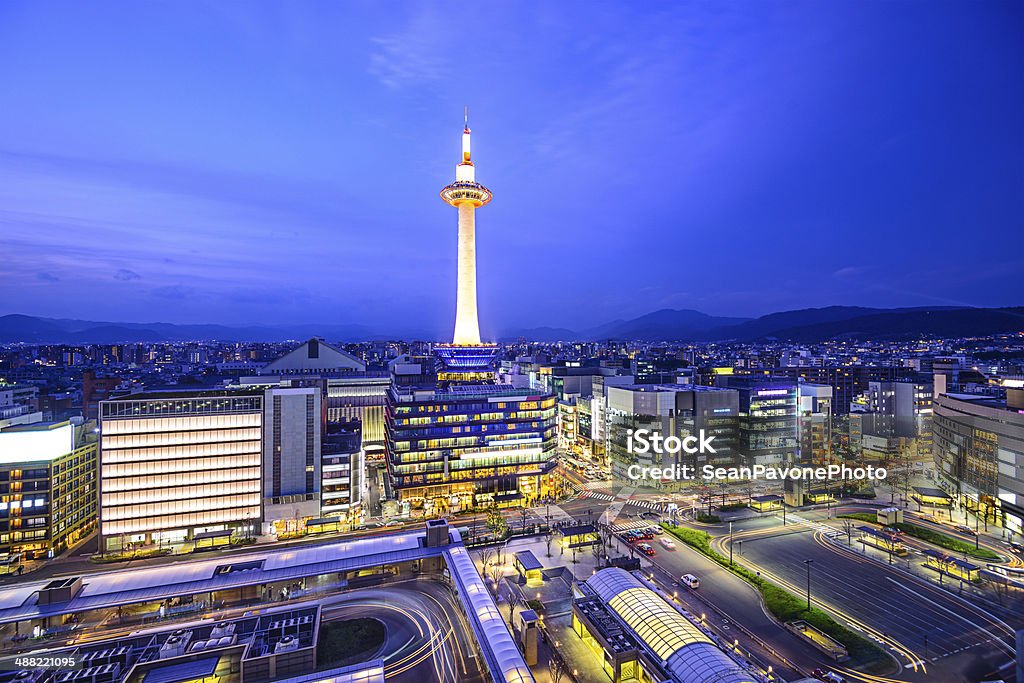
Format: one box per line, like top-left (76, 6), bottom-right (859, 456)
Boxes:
top-left (0, 306), bottom-right (1024, 344)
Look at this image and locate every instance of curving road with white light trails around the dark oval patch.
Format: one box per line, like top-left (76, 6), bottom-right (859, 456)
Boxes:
top-left (322, 581), bottom-right (484, 683)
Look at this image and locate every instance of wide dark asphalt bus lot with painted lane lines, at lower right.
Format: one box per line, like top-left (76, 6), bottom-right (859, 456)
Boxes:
top-left (715, 514), bottom-right (1024, 681)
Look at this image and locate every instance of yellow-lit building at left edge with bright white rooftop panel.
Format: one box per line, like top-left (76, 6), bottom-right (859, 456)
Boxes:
top-left (0, 419), bottom-right (96, 566)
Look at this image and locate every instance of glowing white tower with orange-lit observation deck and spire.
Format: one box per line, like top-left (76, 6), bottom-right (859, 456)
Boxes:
top-left (441, 111), bottom-right (493, 346)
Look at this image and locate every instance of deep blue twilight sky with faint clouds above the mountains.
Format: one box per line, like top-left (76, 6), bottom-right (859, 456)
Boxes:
top-left (0, 0), bottom-right (1024, 336)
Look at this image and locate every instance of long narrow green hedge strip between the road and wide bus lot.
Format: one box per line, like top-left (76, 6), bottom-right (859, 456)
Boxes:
top-left (663, 524), bottom-right (885, 664)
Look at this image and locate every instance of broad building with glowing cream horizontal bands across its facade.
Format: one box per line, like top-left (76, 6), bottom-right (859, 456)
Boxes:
top-left (99, 387), bottom-right (265, 552)
